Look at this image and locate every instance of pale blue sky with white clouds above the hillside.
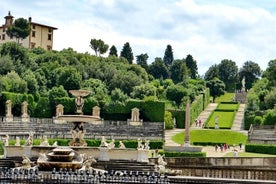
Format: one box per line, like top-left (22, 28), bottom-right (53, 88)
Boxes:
top-left (0, 0), bottom-right (276, 75)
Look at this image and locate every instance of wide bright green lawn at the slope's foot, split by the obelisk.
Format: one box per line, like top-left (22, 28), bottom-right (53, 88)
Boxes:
top-left (172, 129), bottom-right (247, 145)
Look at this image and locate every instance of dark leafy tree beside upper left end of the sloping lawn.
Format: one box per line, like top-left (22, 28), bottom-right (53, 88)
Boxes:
top-left (206, 78), bottom-right (225, 102)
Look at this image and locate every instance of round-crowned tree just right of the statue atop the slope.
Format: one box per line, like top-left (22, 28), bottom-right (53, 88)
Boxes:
top-left (239, 61), bottom-right (261, 91)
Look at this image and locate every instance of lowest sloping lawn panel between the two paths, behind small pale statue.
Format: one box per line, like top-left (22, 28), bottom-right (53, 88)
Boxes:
top-left (205, 111), bottom-right (235, 129)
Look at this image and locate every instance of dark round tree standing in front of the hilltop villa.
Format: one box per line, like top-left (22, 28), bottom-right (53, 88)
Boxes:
top-left (6, 18), bottom-right (31, 43)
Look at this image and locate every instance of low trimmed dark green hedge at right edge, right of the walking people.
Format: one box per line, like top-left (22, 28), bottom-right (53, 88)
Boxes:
top-left (245, 144), bottom-right (276, 155)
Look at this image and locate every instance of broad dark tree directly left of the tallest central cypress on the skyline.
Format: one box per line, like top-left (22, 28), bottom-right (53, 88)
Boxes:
top-left (148, 57), bottom-right (169, 79)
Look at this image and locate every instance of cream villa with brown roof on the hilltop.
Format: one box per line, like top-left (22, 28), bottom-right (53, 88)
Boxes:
top-left (0, 12), bottom-right (57, 50)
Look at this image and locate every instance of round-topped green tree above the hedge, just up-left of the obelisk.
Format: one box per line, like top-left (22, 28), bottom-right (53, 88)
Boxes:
top-left (166, 84), bottom-right (188, 107)
